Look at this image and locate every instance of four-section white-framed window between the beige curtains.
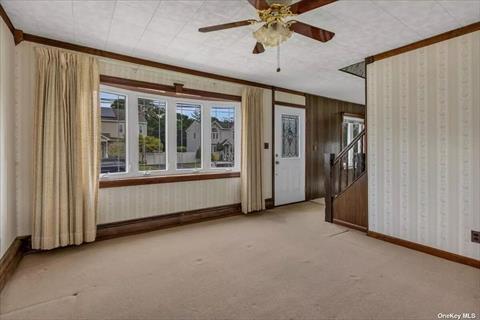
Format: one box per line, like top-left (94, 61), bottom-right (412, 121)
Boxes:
top-left (100, 85), bottom-right (240, 178)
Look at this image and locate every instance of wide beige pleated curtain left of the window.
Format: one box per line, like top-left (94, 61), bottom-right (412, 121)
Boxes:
top-left (32, 48), bottom-right (100, 249)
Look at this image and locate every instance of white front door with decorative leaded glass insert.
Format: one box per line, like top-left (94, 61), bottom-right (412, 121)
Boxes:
top-left (274, 106), bottom-right (305, 206)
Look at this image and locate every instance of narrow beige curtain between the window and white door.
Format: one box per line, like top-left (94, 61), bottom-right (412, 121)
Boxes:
top-left (241, 88), bottom-right (265, 213)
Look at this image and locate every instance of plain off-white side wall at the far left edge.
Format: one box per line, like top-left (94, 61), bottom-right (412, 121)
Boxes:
top-left (0, 19), bottom-right (17, 258)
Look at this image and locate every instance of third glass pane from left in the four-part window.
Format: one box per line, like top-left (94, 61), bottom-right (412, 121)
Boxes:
top-left (177, 103), bottom-right (202, 169)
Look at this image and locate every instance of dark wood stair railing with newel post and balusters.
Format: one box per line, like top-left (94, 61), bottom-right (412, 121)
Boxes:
top-left (324, 130), bottom-right (367, 222)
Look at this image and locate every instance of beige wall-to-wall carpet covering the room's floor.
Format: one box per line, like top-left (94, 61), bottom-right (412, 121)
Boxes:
top-left (0, 202), bottom-right (480, 319)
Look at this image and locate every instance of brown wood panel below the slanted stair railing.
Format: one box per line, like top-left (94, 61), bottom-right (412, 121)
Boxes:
top-left (333, 173), bottom-right (368, 231)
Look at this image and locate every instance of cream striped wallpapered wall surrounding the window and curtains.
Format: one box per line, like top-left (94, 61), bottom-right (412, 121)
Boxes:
top-left (16, 41), bottom-right (272, 235)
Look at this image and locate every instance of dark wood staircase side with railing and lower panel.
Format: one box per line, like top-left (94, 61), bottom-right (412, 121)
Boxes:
top-left (324, 130), bottom-right (368, 231)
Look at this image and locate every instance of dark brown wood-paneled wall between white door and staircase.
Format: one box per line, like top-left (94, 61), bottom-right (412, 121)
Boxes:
top-left (305, 94), bottom-right (365, 200)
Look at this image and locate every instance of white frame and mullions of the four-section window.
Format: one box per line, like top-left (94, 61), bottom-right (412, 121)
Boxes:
top-left (100, 84), bottom-right (242, 180)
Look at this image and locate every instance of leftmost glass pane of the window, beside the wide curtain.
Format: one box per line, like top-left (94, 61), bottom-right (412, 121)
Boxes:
top-left (100, 92), bottom-right (127, 173)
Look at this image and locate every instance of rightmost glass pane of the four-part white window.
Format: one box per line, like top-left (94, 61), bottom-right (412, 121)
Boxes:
top-left (211, 107), bottom-right (235, 168)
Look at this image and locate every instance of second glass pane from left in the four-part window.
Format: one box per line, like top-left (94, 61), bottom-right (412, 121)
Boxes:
top-left (138, 98), bottom-right (167, 171)
